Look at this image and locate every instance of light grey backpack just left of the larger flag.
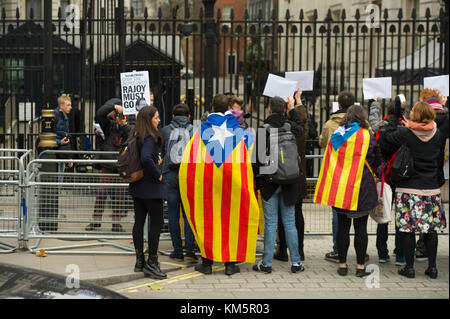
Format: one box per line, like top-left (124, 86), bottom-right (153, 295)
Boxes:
top-left (164, 123), bottom-right (194, 170)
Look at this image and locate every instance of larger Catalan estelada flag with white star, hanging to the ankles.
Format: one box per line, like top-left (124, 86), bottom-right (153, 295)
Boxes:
top-left (179, 112), bottom-right (259, 263)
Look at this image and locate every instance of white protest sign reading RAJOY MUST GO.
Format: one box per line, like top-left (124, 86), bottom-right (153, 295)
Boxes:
top-left (120, 71), bottom-right (150, 115)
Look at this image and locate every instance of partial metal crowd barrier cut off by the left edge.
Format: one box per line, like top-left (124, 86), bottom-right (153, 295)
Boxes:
top-left (0, 149), bottom-right (31, 253)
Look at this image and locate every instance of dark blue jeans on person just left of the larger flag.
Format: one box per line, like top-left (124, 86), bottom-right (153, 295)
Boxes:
top-left (163, 171), bottom-right (194, 254)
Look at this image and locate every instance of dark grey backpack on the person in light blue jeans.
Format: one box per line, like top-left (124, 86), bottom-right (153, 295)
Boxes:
top-left (263, 122), bottom-right (301, 185)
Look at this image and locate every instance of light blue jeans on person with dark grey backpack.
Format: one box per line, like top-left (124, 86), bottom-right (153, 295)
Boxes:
top-left (261, 187), bottom-right (301, 267)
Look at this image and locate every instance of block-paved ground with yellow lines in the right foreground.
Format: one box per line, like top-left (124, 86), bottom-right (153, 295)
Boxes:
top-left (108, 235), bottom-right (449, 299)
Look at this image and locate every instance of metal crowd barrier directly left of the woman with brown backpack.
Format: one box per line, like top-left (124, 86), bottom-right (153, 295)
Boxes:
top-left (24, 151), bottom-right (135, 254)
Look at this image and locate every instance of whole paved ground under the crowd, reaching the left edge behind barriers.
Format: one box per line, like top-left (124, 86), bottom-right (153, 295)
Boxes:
top-left (0, 235), bottom-right (449, 300)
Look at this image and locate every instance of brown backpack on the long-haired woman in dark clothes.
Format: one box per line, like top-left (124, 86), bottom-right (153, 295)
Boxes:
top-left (116, 136), bottom-right (144, 183)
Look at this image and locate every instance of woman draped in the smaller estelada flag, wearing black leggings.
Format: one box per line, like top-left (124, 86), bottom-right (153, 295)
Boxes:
top-left (314, 105), bottom-right (382, 277)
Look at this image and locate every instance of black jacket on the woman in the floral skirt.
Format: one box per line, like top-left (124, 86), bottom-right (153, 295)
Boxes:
top-left (382, 118), bottom-right (445, 189)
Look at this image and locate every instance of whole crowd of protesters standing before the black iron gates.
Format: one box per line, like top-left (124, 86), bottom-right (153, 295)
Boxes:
top-left (51, 85), bottom-right (449, 279)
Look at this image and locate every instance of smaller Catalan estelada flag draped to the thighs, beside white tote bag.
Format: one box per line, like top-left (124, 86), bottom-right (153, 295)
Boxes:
top-left (314, 123), bottom-right (370, 211)
